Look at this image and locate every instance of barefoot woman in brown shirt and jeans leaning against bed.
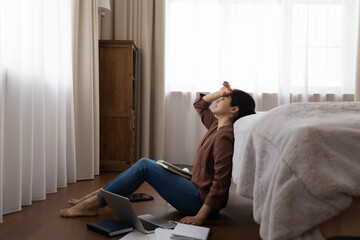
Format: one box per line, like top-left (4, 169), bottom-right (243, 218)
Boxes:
top-left (60, 82), bottom-right (255, 225)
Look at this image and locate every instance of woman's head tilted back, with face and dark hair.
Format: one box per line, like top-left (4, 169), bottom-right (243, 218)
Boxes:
top-left (213, 89), bottom-right (255, 123)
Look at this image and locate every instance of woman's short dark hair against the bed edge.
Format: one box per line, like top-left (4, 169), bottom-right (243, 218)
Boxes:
top-left (230, 89), bottom-right (255, 123)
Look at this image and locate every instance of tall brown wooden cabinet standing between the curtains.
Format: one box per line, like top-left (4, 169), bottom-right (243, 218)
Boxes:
top-left (99, 40), bottom-right (137, 171)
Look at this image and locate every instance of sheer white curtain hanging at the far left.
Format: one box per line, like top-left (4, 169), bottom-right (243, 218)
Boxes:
top-left (0, 0), bottom-right (76, 221)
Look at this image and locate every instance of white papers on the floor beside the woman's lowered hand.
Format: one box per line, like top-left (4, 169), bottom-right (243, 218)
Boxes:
top-left (155, 223), bottom-right (210, 240)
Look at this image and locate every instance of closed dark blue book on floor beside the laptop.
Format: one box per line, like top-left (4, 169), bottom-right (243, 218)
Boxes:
top-left (86, 219), bottom-right (133, 237)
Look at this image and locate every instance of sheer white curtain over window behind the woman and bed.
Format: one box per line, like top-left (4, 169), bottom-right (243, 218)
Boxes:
top-left (165, 0), bottom-right (359, 164)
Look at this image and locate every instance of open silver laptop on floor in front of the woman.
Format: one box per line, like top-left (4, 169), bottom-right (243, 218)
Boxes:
top-left (100, 190), bottom-right (176, 233)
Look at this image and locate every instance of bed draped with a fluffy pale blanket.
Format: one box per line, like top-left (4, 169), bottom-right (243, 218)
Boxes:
top-left (232, 102), bottom-right (360, 240)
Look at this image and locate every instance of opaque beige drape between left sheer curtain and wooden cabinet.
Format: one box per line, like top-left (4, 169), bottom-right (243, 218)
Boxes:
top-left (71, 0), bottom-right (100, 180)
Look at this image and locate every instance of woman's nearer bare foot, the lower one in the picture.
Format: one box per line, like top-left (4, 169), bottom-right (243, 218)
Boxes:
top-left (60, 196), bottom-right (101, 217)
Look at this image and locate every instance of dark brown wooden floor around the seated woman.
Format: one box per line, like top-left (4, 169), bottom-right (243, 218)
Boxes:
top-left (0, 172), bottom-right (260, 240)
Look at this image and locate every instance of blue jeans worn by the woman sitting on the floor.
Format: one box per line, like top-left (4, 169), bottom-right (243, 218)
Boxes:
top-left (97, 158), bottom-right (204, 216)
